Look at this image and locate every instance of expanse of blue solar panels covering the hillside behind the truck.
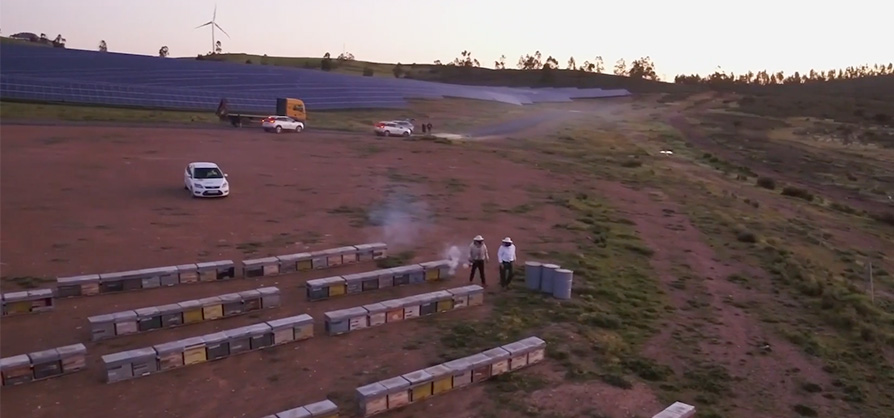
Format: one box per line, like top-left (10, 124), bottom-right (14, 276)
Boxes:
top-left (0, 44), bottom-right (630, 113)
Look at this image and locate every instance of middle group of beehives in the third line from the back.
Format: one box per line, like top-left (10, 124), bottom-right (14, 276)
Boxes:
top-left (102, 314), bottom-right (314, 383)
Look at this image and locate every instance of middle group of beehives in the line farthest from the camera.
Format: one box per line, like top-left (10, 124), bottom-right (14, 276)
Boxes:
top-left (56, 260), bottom-right (236, 297)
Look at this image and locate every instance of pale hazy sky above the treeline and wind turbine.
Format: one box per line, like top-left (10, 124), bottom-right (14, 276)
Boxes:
top-left (0, 0), bottom-right (894, 77)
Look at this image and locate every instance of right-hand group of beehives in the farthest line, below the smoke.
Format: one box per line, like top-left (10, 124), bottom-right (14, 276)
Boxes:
top-left (242, 242), bottom-right (388, 278)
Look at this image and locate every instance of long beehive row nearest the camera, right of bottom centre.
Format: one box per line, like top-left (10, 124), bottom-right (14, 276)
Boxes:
top-left (357, 337), bottom-right (546, 417)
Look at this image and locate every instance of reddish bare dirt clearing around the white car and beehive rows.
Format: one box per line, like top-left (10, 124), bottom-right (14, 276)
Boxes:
top-left (0, 126), bottom-right (580, 418)
